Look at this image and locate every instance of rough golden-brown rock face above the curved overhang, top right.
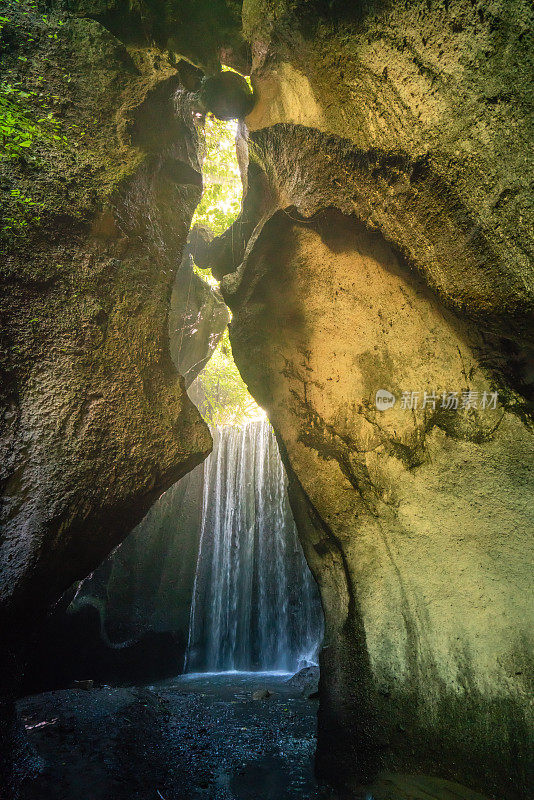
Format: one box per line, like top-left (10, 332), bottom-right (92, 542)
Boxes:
top-left (243, 0), bottom-right (534, 310)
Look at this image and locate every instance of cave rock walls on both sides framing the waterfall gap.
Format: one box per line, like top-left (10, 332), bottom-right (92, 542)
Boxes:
top-left (0, 0), bottom-right (533, 798)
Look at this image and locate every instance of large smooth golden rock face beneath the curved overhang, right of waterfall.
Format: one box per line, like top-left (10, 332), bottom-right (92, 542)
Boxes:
top-left (228, 203), bottom-right (534, 796)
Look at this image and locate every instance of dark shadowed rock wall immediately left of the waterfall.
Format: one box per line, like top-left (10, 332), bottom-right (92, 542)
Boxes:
top-left (21, 464), bottom-right (204, 694)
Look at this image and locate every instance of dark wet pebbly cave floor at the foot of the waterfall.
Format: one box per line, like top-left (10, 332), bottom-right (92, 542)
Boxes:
top-left (18, 673), bottom-right (494, 800)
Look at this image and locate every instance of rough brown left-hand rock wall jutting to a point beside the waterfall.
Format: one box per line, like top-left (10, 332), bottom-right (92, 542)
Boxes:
top-left (0, 1), bottom-right (228, 796)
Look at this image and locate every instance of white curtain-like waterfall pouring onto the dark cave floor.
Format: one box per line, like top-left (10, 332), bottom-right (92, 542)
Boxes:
top-left (186, 420), bottom-right (322, 672)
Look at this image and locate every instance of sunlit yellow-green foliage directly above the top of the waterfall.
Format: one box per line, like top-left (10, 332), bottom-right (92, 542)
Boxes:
top-left (191, 329), bottom-right (264, 425)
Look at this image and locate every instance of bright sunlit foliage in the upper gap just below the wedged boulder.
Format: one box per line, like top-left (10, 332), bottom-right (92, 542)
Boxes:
top-left (193, 115), bottom-right (242, 236)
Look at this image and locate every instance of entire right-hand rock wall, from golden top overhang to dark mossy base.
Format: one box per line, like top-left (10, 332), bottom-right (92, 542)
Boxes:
top-left (210, 0), bottom-right (534, 798)
